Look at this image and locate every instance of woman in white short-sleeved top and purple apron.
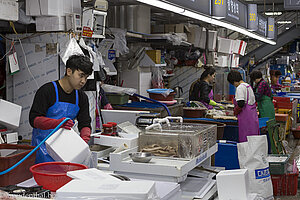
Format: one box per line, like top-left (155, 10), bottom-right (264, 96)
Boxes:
top-left (227, 70), bottom-right (259, 142)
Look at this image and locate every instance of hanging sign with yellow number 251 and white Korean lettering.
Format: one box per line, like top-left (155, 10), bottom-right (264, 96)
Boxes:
top-left (212, 0), bottom-right (247, 28)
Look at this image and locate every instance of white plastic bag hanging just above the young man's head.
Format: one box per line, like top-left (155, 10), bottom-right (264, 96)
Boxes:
top-left (59, 38), bottom-right (84, 64)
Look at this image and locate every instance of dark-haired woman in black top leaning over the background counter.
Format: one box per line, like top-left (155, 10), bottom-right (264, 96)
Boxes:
top-left (189, 67), bottom-right (223, 109)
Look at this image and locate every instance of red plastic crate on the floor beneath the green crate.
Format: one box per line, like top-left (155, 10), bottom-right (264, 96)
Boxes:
top-left (271, 170), bottom-right (299, 196)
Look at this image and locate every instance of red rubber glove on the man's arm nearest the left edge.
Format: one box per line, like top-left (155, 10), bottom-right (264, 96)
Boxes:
top-left (33, 116), bottom-right (74, 130)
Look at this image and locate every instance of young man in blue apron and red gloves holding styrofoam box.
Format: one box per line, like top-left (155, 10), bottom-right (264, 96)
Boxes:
top-left (29, 55), bottom-right (93, 163)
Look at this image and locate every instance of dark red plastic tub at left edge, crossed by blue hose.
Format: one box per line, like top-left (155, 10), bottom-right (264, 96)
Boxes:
top-left (0, 144), bottom-right (36, 186)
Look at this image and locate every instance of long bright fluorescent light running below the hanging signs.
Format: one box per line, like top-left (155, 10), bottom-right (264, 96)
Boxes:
top-left (137, 0), bottom-right (276, 45)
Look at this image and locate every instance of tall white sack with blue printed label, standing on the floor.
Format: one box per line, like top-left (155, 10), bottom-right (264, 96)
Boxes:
top-left (237, 135), bottom-right (273, 200)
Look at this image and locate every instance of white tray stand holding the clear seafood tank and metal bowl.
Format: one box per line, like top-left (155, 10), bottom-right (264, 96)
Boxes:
top-left (110, 144), bottom-right (218, 182)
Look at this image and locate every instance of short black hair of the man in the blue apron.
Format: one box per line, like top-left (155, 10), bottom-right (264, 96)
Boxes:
top-left (66, 55), bottom-right (93, 75)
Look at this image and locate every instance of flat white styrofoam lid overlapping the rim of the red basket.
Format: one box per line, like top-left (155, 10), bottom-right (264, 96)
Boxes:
top-left (67, 168), bottom-right (121, 182)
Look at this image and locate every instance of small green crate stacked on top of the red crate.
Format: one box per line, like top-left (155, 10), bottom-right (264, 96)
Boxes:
top-left (267, 154), bottom-right (290, 174)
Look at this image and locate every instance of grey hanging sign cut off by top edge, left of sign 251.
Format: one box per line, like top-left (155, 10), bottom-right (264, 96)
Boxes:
top-left (167, 0), bottom-right (211, 15)
